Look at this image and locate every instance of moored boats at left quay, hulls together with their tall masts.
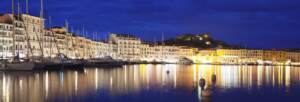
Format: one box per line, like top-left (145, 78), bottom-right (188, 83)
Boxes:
top-left (0, 0), bottom-right (122, 71)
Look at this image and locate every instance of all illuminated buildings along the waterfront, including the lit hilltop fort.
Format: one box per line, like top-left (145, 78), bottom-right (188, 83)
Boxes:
top-left (0, 14), bottom-right (300, 65)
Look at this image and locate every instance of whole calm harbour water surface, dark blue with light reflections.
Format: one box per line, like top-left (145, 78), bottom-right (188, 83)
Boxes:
top-left (0, 64), bottom-right (300, 102)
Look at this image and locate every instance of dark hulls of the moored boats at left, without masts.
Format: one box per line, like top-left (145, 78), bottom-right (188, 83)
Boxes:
top-left (0, 54), bottom-right (123, 71)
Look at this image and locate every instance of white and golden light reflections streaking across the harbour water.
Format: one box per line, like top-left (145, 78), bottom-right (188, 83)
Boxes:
top-left (0, 65), bottom-right (300, 102)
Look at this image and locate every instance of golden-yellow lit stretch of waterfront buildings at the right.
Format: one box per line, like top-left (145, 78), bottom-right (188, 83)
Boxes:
top-left (192, 49), bottom-right (300, 65)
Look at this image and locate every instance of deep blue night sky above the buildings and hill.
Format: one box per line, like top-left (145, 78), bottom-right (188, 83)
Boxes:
top-left (0, 0), bottom-right (300, 48)
